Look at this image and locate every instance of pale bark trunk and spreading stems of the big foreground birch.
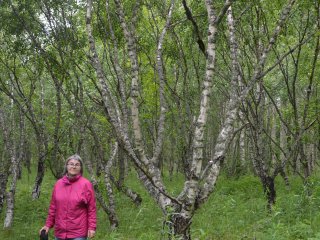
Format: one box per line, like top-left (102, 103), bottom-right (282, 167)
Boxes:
top-left (86, 0), bottom-right (294, 236)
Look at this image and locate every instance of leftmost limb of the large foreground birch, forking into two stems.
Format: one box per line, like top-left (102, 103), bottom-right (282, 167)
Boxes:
top-left (86, 0), bottom-right (171, 216)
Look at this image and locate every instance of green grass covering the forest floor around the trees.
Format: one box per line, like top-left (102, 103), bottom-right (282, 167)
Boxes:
top-left (0, 169), bottom-right (320, 240)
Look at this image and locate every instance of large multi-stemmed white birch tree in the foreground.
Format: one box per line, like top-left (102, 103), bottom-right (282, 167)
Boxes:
top-left (86, 0), bottom-right (295, 239)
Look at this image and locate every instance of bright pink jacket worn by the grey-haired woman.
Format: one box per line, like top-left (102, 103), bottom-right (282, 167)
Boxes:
top-left (46, 175), bottom-right (97, 239)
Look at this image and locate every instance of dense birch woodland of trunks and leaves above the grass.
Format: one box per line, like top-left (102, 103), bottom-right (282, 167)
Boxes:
top-left (0, 0), bottom-right (320, 239)
